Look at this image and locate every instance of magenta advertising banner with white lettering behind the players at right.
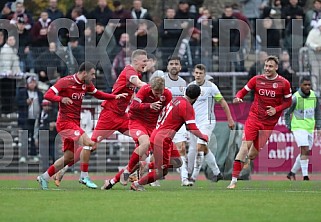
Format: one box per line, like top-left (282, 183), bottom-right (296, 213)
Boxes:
top-left (215, 103), bottom-right (321, 173)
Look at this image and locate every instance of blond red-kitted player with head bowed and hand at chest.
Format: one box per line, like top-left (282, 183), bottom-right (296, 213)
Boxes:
top-left (101, 77), bottom-right (172, 190)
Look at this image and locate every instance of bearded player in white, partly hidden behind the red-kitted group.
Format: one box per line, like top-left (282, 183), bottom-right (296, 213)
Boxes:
top-left (151, 56), bottom-right (190, 186)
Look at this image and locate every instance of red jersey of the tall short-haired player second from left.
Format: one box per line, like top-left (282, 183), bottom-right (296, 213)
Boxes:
top-left (102, 65), bottom-right (142, 115)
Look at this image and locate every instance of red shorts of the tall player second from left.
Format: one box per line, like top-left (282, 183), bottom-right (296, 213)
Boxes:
top-left (91, 109), bottom-right (129, 142)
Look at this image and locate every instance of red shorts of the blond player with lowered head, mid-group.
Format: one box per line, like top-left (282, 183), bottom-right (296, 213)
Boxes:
top-left (128, 120), bottom-right (155, 146)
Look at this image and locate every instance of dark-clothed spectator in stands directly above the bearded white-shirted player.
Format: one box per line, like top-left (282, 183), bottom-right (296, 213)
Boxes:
top-left (159, 8), bottom-right (181, 70)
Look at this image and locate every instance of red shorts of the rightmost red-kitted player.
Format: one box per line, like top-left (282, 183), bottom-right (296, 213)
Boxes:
top-left (242, 119), bottom-right (274, 151)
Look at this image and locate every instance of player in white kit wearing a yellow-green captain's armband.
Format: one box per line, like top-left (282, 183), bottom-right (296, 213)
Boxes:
top-left (188, 64), bottom-right (235, 185)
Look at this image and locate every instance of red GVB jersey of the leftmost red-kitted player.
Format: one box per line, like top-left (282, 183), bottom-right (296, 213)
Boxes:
top-left (51, 74), bottom-right (97, 121)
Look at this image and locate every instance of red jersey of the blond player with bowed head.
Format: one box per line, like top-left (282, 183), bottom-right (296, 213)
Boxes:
top-left (129, 85), bottom-right (172, 126)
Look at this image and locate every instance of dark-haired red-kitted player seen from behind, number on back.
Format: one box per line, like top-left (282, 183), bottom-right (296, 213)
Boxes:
top-left (130, 84), bottom-right (208, 191)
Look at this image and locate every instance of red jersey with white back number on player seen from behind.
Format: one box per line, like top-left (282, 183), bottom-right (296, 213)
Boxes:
top-left (151, 96), bottom-right (195, 141)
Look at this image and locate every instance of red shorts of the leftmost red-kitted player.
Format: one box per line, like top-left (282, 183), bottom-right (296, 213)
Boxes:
top-left (56, 121), bottom-right (85, 152)
